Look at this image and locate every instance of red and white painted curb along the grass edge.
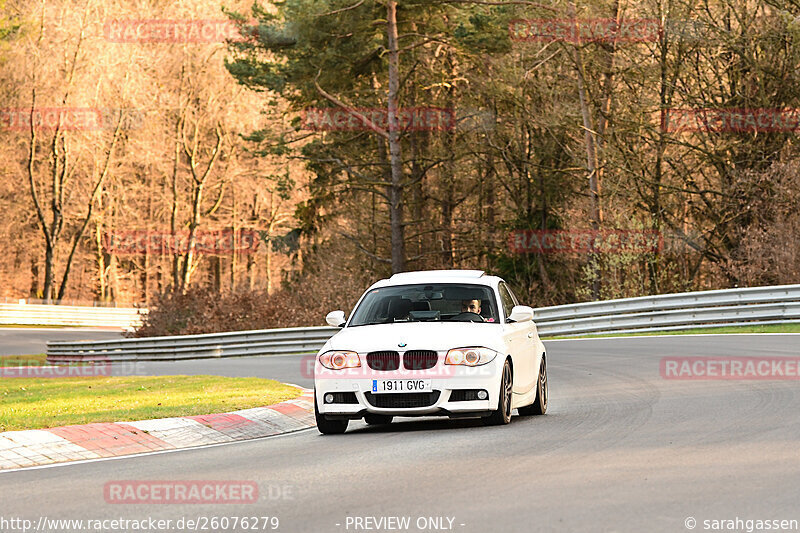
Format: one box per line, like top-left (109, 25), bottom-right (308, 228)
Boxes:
top-left (0, 389), bottom-right (315, 470)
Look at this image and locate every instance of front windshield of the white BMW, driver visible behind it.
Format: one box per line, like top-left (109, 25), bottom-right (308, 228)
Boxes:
top-left (349, 283), bottom-right (499, 326)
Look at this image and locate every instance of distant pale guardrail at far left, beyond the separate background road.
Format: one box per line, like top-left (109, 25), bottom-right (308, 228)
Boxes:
top-left (0, 303), bottom-right (147, 329)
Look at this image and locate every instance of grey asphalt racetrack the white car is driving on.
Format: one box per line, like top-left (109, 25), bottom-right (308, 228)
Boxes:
top-left (0, 335), bottom-right (800, 533)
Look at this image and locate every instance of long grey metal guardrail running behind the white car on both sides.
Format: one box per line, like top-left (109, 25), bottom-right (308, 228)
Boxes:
top-left (47, 285), bottom-right (800, 363)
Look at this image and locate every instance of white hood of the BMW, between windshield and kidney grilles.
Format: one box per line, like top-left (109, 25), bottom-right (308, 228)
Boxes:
top-left (324, 322), bottom-right (505, 353)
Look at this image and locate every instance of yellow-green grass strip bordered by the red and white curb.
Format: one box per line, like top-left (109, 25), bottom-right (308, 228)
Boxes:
top-left (0, 376), bottom-right (301, 432)
